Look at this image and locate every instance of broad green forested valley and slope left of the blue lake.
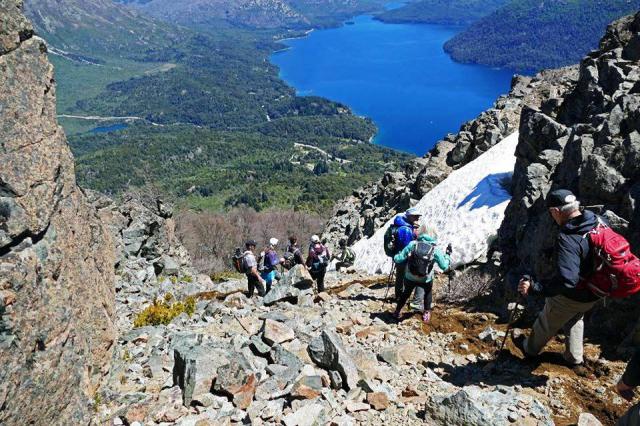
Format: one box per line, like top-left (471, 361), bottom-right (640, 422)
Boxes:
top-left (27, 0), bottom-right (409, 211)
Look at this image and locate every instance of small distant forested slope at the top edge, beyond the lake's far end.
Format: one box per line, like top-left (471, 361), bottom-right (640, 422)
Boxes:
top-left (376, 0), bottom-right (508, 25)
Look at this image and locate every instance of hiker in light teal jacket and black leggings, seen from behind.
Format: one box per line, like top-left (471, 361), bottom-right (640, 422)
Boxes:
top-left (393, 225), bottom-right (451, 323)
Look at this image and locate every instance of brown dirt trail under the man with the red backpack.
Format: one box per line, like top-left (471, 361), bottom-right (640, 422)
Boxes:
top-left (330, 278), bottom-right (629, 426)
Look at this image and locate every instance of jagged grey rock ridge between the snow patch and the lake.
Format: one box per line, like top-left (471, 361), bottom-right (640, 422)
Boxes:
top-left (324, 67), bottom-right (578, 253)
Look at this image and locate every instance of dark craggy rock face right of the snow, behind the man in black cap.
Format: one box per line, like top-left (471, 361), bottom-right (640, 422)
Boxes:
top-left (500, 10), bottom-right (640, 277)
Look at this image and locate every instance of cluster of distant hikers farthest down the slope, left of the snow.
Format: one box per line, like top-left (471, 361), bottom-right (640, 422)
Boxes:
top-left (234, 235), bottom-right (355, 297)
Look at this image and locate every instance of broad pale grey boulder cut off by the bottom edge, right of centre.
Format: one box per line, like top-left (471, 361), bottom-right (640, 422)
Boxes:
top-left (426, 386), bottom-right (554, 426)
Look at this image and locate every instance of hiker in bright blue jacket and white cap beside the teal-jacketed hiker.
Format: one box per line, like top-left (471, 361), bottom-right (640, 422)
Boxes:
top-left (385, 208), bottom-right (424, 309)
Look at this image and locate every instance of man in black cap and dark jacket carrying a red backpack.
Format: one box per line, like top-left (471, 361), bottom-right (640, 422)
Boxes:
top-left (515, 189), bottom-right (640, 375)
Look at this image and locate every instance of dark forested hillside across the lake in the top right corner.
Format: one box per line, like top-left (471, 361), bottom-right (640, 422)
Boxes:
top-left (445, 0), bottom-right (640, 71)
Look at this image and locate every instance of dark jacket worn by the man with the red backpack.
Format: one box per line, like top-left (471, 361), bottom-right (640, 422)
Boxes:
top-left (534, 210), bottom-right (598, 302)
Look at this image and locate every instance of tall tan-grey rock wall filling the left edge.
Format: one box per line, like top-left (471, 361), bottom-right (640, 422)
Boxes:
top-left (0, 0), bottom-right (115, 424)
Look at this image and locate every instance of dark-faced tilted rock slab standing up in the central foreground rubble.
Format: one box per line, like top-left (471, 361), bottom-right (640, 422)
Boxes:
top-left (308, 330), bottom-right (360, 389)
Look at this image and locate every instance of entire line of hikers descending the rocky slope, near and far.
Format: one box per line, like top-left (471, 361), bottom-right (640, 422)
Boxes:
top-left (234, 189), bottom-right (640, 426)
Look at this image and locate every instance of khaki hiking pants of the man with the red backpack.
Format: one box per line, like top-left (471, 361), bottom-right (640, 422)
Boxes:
top-left (524, 295), bottom-right (597, 364)
